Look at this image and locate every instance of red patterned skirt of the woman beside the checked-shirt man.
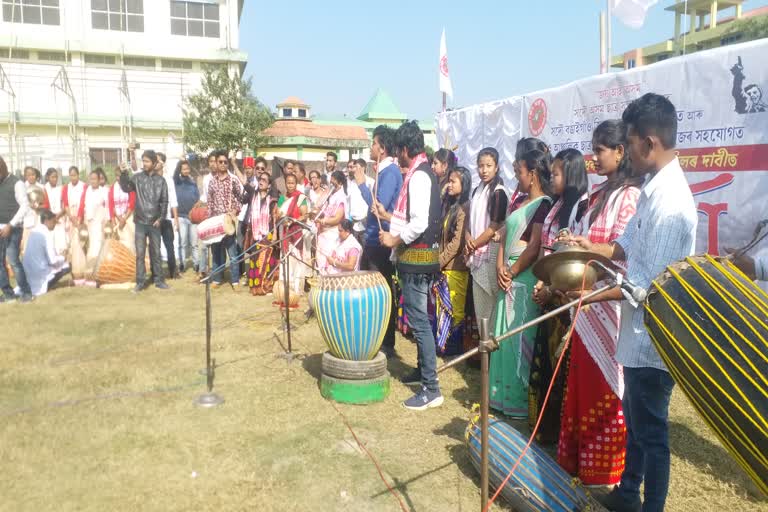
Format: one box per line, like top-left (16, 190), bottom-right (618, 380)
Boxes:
top-left (557, 331), bottom-right (627, 485)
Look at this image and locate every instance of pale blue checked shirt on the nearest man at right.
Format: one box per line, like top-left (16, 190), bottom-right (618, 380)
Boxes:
top-left (615, 158), bottom-right (698, 371)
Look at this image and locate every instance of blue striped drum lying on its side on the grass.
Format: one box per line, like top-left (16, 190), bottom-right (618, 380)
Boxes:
top-left (466, 416), bottom-right (605, 512)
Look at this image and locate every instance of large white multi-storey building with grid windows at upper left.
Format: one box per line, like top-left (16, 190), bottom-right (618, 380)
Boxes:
top-left (0, 0), bottom-right (247, 172)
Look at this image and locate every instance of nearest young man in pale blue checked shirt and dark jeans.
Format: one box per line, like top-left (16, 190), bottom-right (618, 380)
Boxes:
top-left (573, 93), bottom-right (698, 512)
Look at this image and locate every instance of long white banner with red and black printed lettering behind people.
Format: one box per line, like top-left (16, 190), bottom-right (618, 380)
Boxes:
top-left (436, 40), bottom-right (768, 254)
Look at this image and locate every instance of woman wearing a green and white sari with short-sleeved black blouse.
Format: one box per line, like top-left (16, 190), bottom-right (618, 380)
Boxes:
top-left (490, 150), bottom-right (552, 418)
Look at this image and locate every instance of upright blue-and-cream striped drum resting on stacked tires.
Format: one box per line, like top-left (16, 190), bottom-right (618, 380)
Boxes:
top-left (310, 272), bottom-right (392, 361)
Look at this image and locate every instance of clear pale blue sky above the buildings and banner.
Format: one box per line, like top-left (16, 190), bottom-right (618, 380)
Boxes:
top-left (240, 0), bottom-right (768, 119)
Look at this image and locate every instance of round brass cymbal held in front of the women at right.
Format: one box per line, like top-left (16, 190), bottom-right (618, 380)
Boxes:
top-left (533, 246), bottom-right (615, 291)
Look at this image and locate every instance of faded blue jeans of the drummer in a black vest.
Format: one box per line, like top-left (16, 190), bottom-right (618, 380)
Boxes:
top-left (398, 272), bottom-right (440, 391)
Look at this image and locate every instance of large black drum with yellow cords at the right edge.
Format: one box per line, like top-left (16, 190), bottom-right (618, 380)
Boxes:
top-left (645, 256), bottom-right (768, 494)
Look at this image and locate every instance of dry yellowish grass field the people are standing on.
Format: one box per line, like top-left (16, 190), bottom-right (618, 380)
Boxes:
top-left (0, 278), bottom-right (768, 512)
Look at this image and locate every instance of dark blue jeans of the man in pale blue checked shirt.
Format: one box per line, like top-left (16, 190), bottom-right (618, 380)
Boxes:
top-left (619, 366), bottom-right (675, 512)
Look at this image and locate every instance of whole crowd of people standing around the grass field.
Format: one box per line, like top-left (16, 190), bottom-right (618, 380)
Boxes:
top-left (0, 94), bottom-right (728, 511)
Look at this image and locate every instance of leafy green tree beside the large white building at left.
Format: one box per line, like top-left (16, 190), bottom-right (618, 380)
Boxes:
top-left (184, 67), bottom-right (274, 152)
